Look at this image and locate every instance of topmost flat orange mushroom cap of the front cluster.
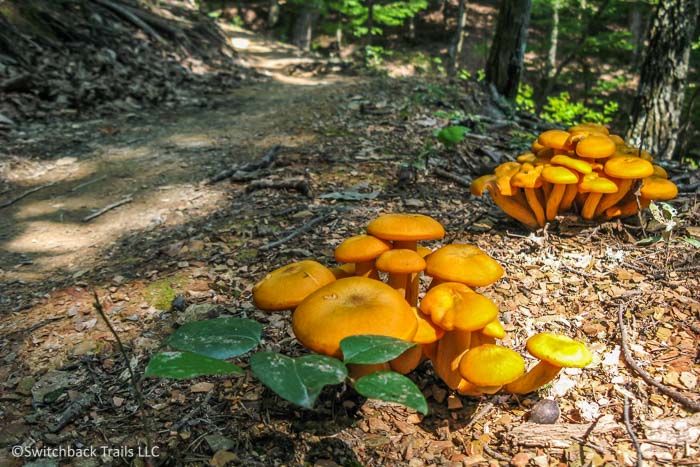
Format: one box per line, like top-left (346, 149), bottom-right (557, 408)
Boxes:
top-left (367, 214), bottom-right (445, 241)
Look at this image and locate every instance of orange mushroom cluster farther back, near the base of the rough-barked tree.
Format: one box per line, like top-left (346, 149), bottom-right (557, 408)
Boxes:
top-left (471, 122), bottom-right (678, 229)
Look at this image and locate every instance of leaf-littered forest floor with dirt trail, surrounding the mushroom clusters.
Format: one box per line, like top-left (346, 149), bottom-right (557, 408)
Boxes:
top-left (0, 22), bottom-right (700, 466)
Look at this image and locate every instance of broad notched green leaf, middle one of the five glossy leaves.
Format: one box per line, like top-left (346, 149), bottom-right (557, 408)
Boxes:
top-left (250, 352), bottom-right (348, 409)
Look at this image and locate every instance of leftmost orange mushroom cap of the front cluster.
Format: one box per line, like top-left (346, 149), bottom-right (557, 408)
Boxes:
top-left (253, 260), bottom-right (335, 311)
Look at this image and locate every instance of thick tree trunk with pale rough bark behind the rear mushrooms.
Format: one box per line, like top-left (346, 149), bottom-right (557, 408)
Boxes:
top-left (627, 0), bottom-right (698, 159)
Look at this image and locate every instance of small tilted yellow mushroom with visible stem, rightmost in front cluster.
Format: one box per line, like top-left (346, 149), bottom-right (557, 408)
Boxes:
top-left (506, 332), bottom-right (593, 394)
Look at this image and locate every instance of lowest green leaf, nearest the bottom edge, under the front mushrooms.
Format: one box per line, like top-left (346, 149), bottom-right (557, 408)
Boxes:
top-left (355, 371), bottom-right (428, 415)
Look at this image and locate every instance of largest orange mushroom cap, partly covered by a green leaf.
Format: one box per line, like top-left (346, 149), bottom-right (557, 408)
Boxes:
top-left (292, 276), bottom-right (418, 358)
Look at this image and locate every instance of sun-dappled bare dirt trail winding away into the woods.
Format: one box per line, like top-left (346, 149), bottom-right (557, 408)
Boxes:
top-left (0, 28), bottom-right (351, 296)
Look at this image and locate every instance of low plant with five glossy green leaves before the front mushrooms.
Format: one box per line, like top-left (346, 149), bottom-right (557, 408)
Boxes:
top-left (145, 317), bottom-right (427, 413)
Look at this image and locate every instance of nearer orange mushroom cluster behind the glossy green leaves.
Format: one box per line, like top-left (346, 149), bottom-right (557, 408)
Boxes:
top-left (253, 214), bottom-right (591, 395)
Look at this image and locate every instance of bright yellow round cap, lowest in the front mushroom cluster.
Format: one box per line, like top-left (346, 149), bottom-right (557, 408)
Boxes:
top-left (459, 344), bottom-right (525, 386)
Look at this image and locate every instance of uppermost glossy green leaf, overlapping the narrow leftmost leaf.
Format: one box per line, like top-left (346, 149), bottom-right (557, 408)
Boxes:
top-left (165, 318), bottom-right (262, 360)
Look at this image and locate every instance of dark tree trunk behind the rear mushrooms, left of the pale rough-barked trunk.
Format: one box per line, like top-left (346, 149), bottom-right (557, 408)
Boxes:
top-left (486, 0), bottom-right (532, 100)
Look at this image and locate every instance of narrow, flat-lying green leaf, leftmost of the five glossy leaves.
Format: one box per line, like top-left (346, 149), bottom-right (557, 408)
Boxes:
top-left (145, 352), bottom-right (243, 379)
